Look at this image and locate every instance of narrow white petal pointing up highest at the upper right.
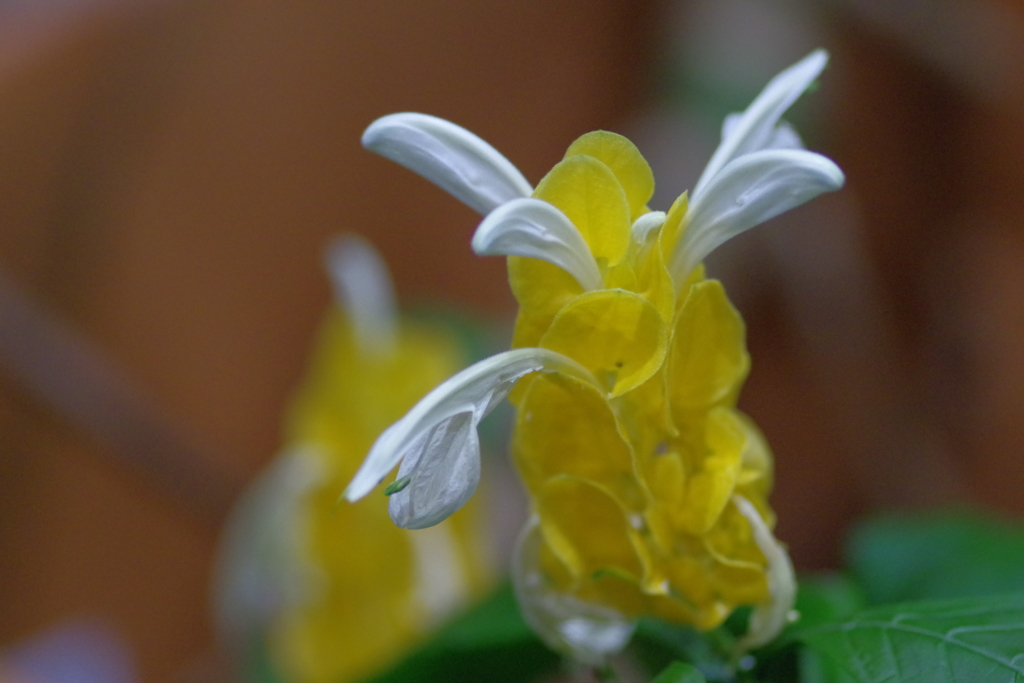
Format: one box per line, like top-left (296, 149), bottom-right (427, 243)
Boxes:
top-left (693, 50), bottom-right (828, 194)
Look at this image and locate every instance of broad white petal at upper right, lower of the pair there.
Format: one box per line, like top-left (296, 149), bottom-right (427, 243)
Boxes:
top-left (671, 150), bottom-right (845, 283)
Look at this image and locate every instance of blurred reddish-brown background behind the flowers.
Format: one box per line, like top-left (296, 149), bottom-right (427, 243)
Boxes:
top-left (0, 0), bottom-right (1024, 682)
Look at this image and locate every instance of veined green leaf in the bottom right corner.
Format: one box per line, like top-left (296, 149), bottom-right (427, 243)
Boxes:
top-left (799, 593), bottom-right (1024, 683)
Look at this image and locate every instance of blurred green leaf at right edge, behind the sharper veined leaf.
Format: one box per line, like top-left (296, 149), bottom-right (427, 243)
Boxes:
top-left (847, 510), bottom-right (1024, 604)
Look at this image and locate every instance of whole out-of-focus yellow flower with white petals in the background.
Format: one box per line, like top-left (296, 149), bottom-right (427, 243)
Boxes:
top-left (214, 238), bottom-right (483, 683)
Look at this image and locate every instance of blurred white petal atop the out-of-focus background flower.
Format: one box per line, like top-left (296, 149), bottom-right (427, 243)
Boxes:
top-left (324, 234), bottom-right (397, 354)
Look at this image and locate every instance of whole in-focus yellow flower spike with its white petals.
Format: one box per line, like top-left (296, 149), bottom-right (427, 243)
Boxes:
top-left (345, 51), bottom-right (843, 661)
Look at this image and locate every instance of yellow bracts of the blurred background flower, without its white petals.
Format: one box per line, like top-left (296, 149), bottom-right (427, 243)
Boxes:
top-left (269, 311), bottom-right (483, 683)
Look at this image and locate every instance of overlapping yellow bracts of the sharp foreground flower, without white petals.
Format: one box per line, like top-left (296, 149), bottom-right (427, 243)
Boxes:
top-left (509, 131), bottom-right (774, 629)
